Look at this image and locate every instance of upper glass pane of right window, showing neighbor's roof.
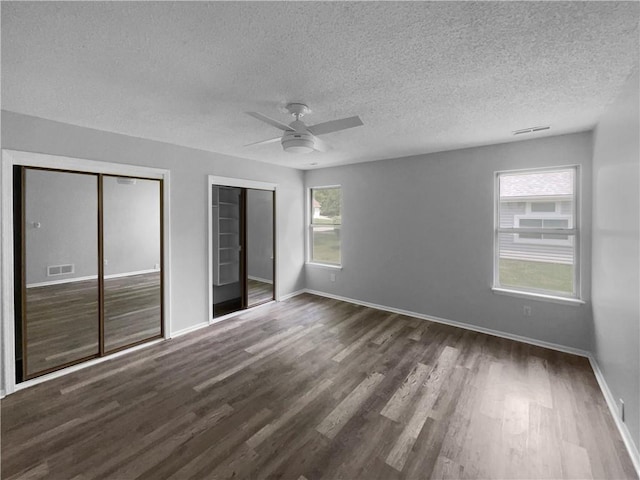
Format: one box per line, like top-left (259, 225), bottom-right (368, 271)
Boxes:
top-left (499, 169), bottom-right (575, 228)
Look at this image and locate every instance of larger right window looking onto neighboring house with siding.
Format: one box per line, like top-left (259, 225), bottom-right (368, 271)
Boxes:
top-left (494, 167), bottom-right (580, 298)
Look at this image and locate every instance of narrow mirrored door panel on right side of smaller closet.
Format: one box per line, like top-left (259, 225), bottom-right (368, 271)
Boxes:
top-left (247, 189), bottom-right (274, 306)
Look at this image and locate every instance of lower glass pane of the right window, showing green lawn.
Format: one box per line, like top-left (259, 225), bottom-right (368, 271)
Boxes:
top-left (498, 233), bottom-right (574, 295)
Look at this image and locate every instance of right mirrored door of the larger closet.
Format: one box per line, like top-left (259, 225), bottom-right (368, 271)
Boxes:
top-left (102, 175), bottom-right (162, 352)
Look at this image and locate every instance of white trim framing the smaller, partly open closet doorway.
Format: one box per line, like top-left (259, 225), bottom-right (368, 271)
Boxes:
top-left (207, 175), bottom-right (280, 316)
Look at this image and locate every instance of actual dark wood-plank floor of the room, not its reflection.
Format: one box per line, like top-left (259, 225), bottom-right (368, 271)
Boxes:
top-left (1, 294), bottom-right (636, 480)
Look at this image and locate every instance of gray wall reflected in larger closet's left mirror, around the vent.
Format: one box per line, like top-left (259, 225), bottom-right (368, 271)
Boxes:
top-left (25, 169), bottom-right (98, 285)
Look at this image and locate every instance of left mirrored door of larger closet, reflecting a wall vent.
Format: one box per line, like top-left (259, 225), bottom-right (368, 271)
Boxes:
top-left (23, 168), bottom-right (99, 380)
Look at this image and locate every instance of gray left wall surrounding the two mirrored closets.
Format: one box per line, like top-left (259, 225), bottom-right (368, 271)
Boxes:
top-left (2, 111), bottom-right (304, 338)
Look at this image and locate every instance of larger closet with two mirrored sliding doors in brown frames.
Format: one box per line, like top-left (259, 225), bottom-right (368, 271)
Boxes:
top-left (13, 166), bottom-right (164, 383)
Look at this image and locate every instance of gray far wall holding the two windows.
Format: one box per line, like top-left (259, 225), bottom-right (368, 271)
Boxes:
top-left (305, 132), bottom-right (592, 350)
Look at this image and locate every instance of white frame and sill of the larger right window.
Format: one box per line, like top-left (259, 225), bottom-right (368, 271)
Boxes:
top-left (492, 165), bottom-right (584, 304)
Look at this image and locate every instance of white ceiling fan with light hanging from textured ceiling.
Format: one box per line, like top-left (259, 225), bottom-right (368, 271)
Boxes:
top-left (245, 103), bottom-right (364, 153)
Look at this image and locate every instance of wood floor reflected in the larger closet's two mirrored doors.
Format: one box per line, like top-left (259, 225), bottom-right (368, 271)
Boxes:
top-left (26, 272), bottom-right (161, 374)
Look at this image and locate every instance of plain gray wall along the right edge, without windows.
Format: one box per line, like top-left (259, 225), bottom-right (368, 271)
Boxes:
top-left (592, 72), bottom-right (640, 448)
